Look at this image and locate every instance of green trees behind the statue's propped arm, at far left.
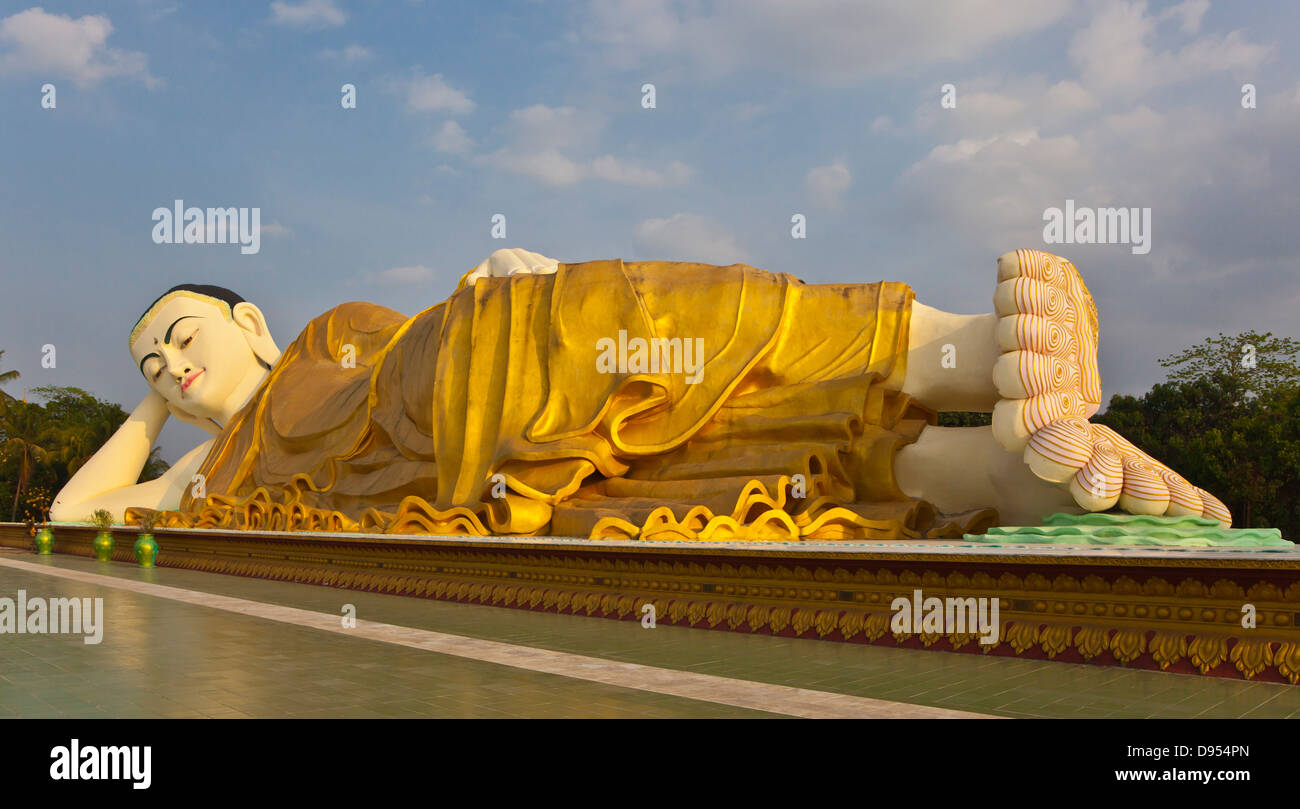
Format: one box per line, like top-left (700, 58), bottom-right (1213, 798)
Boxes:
top-left (0, 375), bottom-right (168, 522)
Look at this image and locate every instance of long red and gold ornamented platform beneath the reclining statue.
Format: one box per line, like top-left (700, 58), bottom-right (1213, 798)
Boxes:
top-left (0, 523), bottom-right (1300, 684)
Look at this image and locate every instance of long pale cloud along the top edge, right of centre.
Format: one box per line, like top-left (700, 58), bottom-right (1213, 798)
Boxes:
top-left (584, 0), bottom-right (1071, 83)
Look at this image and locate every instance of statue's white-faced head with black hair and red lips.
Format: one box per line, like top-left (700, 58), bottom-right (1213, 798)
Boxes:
top-left (130, 284), bottom-right (280, 424)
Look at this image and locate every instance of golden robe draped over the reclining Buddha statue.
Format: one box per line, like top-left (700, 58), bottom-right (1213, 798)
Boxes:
top-left (163, 260), bottom-right (996, 540)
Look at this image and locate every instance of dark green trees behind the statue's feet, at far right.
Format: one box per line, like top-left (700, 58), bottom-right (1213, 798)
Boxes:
top-left (1092, 332), bottom-right (1300, 540)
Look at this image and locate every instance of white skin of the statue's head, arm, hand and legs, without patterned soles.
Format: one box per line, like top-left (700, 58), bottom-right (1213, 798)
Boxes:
top-left (49, 250), bottom-right (1222, 524)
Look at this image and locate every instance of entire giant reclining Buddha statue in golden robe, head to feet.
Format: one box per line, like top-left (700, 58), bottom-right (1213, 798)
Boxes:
top-left (51, 250), bottom-right (1231, 541)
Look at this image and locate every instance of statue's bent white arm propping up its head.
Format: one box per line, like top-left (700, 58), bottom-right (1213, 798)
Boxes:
top-left (49, 391), bottom-right (212, 522)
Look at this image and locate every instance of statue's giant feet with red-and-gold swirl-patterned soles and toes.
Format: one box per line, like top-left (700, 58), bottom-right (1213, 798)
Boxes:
top-left (993, 250), bottom-right (1232, 527)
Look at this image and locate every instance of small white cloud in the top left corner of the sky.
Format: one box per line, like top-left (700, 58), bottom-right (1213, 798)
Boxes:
top-left (0, 8), bottom-right (160, 87)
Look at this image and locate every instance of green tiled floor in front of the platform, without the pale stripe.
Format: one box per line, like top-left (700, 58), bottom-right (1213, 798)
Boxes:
top-left (0, 555), bottom-right (1300, 717)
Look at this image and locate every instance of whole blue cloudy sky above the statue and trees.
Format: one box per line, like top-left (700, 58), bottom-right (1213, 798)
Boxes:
top-left (0, 0), bottom-right (1300, 460)
